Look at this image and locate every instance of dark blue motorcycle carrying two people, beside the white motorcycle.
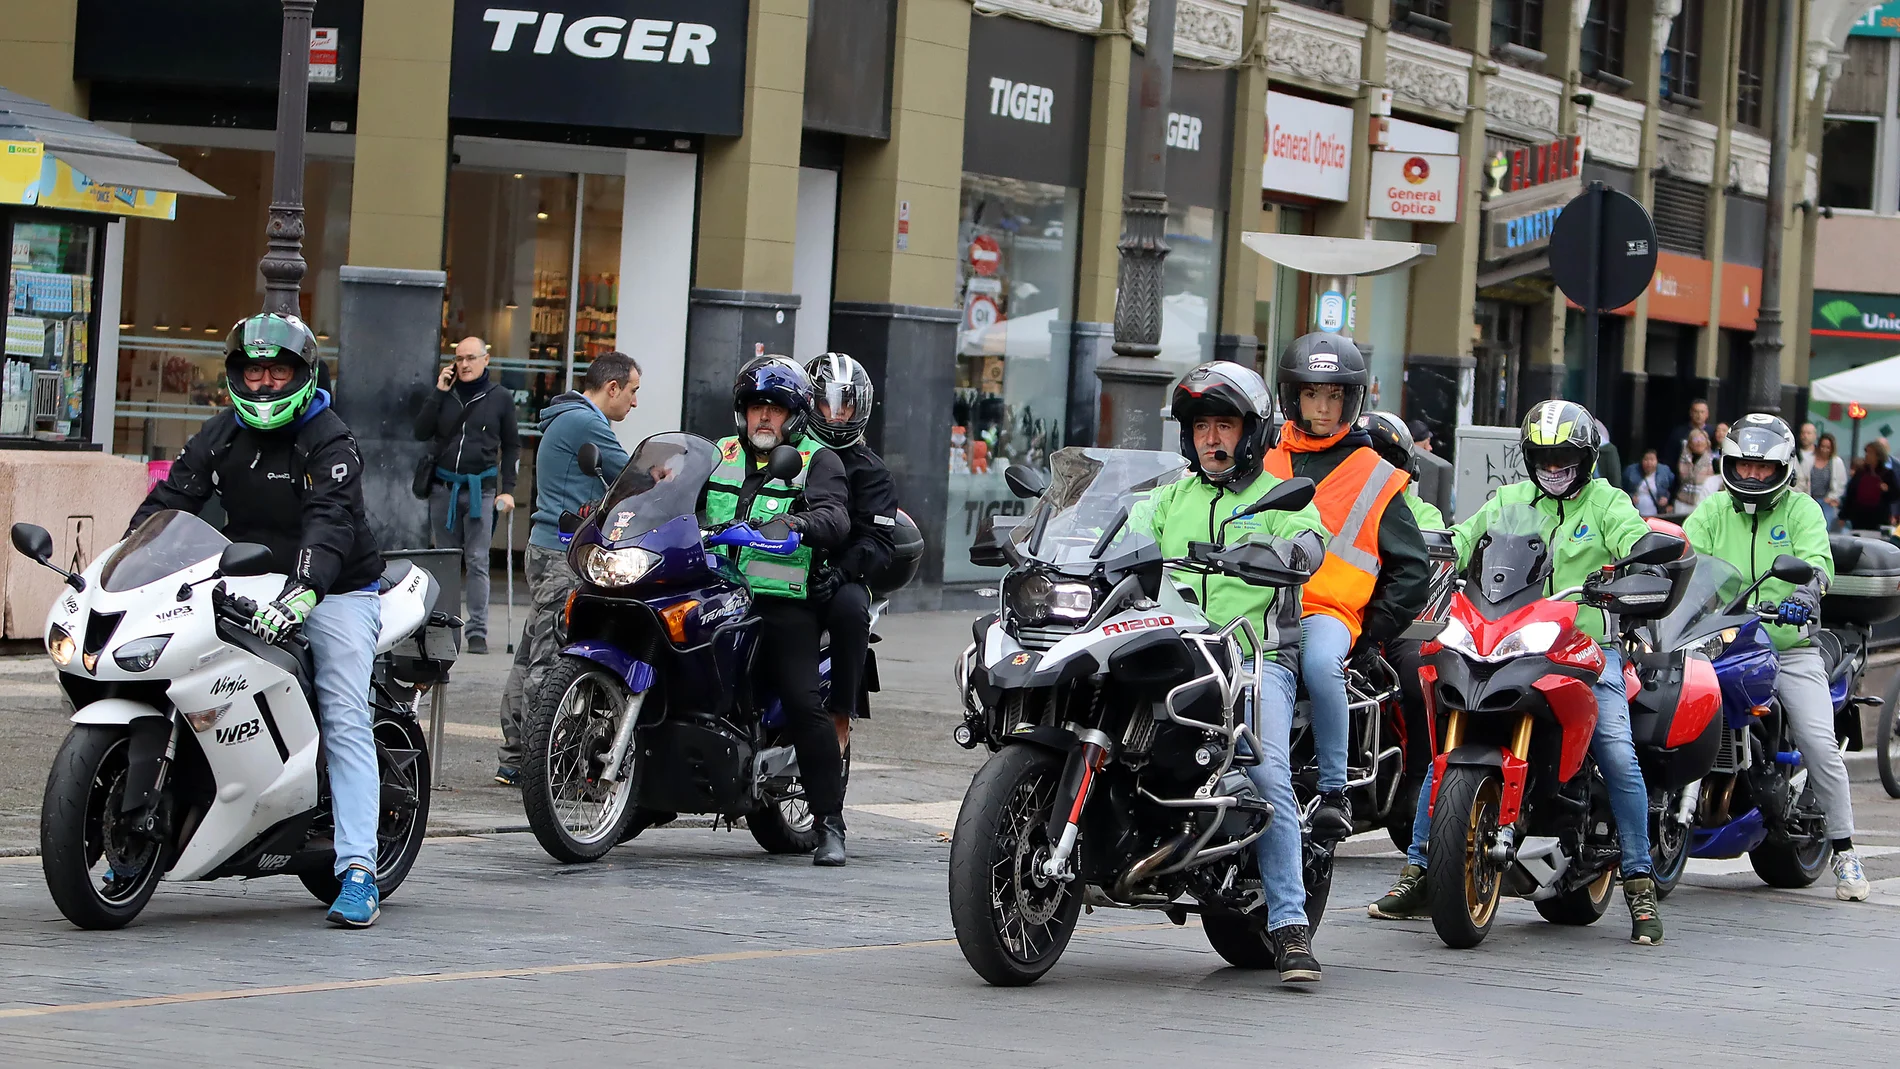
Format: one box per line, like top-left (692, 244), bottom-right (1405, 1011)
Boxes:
top-left (521, 433), bottom-right (922, 862)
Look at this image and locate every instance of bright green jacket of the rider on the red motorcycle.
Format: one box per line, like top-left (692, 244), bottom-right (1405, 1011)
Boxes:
top-left (1452, 478), bottom-right (1649, 642)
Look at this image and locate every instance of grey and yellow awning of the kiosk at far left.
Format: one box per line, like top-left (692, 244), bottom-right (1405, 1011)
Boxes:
top-left (0, 89), bottom-right (228, 211)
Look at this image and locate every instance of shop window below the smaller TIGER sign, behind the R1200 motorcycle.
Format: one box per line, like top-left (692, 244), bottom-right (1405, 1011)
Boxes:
top-left (944, 175), bottom-right (1081, 583)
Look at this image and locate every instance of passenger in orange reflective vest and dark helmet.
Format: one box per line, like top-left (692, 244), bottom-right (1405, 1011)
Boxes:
top-left (1265, 332), bottom-right (1431, 841)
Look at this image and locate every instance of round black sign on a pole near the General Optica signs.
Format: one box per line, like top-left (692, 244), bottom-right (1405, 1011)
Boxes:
top-left (1550, 182), bottom-right (1657, 311)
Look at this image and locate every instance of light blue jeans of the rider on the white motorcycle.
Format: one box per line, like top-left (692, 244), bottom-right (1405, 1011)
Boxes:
top-left (304, 591), bottom-right (382, 875)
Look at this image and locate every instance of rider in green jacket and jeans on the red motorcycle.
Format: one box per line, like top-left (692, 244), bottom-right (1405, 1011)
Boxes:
top-left (1366, 401), bottom-right (1663, 946)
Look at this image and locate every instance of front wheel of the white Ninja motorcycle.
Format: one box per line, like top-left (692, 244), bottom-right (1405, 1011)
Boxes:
top-left (40, 723), bottom-right (171, 930)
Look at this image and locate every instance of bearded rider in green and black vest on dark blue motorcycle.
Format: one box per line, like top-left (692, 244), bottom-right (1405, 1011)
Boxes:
top-left (705, 355), bottom-right (851, 866)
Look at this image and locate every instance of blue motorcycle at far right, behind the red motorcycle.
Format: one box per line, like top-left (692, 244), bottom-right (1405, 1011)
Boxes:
top-left (1632, 554), bottom-right (1830, 894)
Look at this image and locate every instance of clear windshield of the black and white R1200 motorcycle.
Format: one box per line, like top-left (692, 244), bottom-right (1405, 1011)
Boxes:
top-left (1009, 446), bottom-right (1188, 568)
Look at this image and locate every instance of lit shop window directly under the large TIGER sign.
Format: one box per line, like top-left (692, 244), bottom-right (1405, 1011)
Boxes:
top-left (443, 165), bottom-right (627, 437)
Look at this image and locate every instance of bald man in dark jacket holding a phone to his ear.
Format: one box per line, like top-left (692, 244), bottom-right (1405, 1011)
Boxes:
top-left (416, 336), bottom-right (521, 653)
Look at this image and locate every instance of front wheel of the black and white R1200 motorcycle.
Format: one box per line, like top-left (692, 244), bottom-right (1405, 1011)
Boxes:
top-left (950, 744), bottom-right (1083, 987)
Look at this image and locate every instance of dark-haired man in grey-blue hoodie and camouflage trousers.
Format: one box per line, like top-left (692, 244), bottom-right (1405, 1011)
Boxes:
top-left (494, 353), bottom-right (640, 786)
